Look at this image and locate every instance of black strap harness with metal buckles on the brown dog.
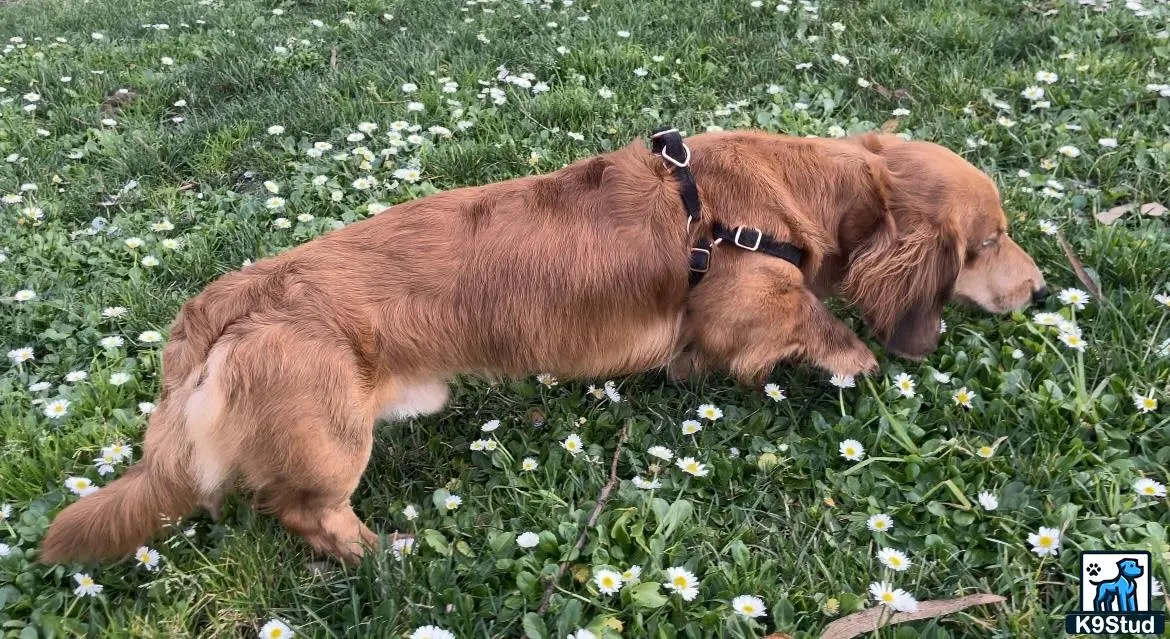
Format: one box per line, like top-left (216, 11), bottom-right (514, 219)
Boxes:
top-left (651, 126), bottom-right (804, 288)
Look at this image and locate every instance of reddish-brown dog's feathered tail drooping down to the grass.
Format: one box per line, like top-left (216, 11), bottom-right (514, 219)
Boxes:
top-left (41, 264), bottom-right (282, 563)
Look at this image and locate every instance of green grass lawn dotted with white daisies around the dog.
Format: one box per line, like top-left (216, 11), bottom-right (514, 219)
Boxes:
top-left (0, 0), bottom-right (1170, 639)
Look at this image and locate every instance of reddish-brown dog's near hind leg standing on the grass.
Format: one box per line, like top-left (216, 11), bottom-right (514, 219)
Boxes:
top-left (229, 323), bottom-right (393, 563)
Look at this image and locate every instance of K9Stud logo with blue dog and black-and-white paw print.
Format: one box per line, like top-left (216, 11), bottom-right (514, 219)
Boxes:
top-left (1065, 550), bottom-right (1165, 634)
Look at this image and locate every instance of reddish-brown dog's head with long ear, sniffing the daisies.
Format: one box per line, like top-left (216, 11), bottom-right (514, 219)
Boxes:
top-left (844, 135), bottom-right (1047, 359)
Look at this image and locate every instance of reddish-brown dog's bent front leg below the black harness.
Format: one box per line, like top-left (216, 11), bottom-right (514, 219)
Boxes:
top-left (688, 255), bottom-right (878, 385)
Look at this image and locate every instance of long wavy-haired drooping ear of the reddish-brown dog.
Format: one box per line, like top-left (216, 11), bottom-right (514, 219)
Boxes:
top-left (842, 136), bottom-right (963, 359)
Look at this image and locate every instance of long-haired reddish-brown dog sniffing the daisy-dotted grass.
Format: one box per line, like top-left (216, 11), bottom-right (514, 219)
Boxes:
top-left (41, 131), bottom-right (1046, 563)
